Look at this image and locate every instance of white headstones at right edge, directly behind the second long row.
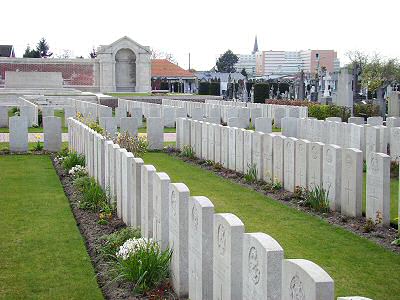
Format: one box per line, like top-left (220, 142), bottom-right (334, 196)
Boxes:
top-left (282, 117), bottom-right (400, 161)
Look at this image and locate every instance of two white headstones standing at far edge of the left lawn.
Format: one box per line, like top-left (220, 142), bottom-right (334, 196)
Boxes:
top-left (9, 116), bottom-right (62, 152)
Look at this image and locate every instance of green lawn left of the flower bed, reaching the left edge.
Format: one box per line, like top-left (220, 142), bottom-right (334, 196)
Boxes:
top-left (0, 155), bottom-right (103, 299)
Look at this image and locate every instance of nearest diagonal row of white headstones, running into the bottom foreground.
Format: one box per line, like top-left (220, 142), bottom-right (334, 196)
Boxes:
top-left (68, 118), bottom-right (376, 300)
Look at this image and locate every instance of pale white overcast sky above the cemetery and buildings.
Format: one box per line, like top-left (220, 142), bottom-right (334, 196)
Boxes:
top-left (0, 0), bottom-right (400, 70)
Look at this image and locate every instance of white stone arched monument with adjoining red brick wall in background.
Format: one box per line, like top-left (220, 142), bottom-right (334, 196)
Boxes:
top-left (0, 36), bottom-right (151, 93)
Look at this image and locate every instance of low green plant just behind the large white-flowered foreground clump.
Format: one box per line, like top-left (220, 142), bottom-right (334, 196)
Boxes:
top-left (100, 227), bottom-right (140, 258)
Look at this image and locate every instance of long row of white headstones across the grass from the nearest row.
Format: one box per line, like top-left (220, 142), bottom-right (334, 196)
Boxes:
top-left (177, 118), bottom-right (390, 225)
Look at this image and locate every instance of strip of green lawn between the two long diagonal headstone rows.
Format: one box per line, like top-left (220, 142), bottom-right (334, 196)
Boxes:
top-left (144, 153), bottom-right (400, 300)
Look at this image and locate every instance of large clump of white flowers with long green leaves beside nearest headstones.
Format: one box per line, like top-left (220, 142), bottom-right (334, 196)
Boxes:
top-left (114, 239), bottom-right (172, 294)
